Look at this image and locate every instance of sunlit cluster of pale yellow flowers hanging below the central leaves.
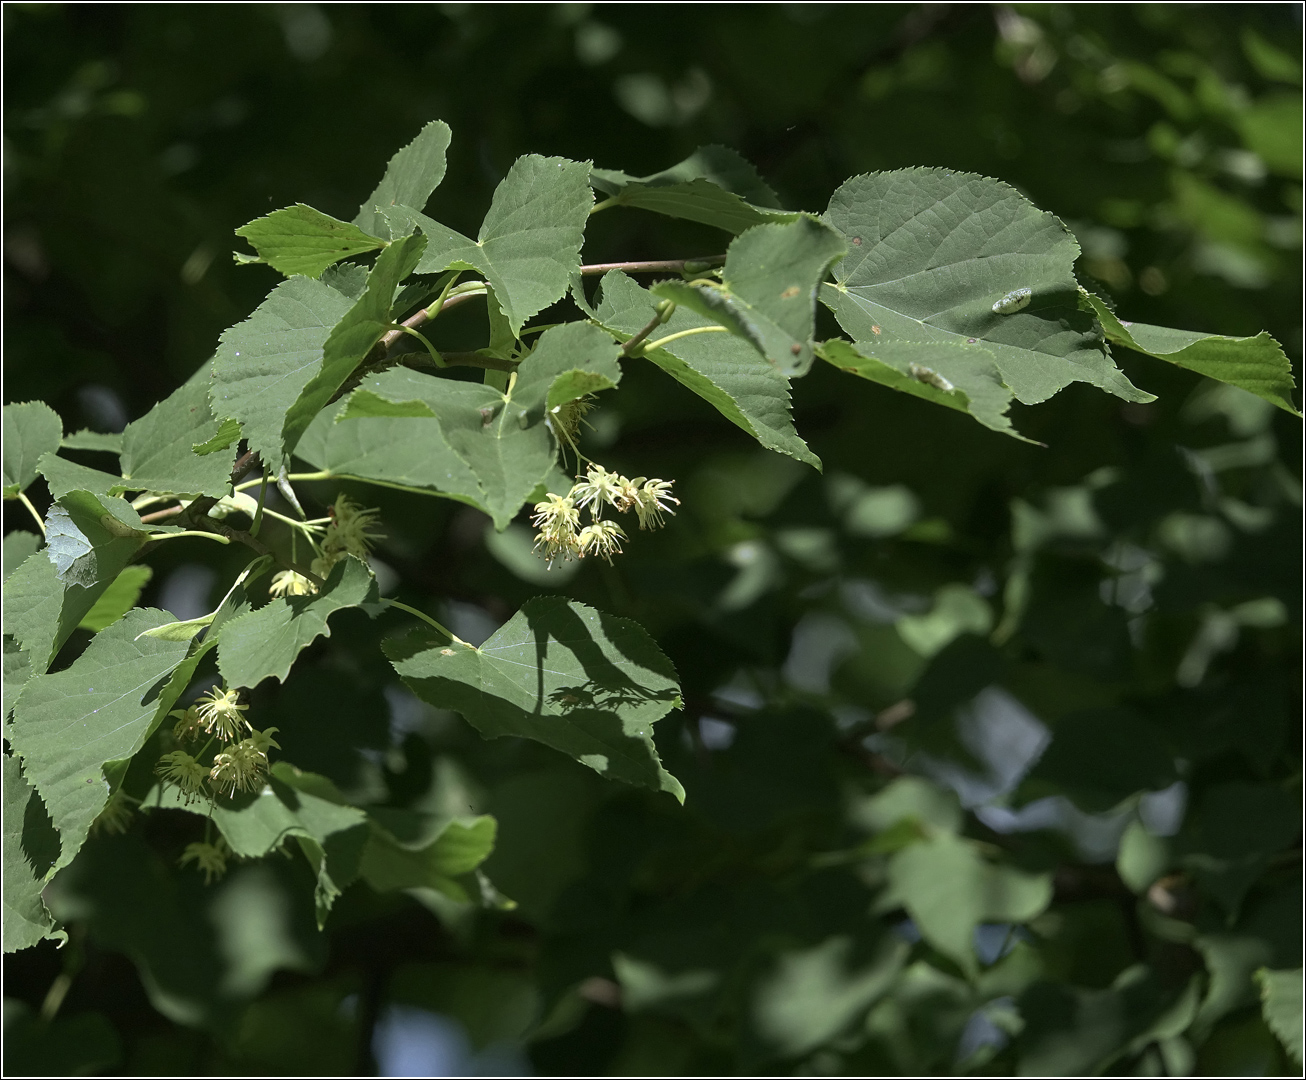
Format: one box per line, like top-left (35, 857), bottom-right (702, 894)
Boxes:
top-left (530, 465), bottom-right (680, 565)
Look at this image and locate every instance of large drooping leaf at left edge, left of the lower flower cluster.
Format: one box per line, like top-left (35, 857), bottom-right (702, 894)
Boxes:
top-left (8, 607), bottom-right (187, 870)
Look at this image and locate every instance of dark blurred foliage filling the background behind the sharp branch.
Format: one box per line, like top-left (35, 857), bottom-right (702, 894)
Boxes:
top-left (4, 4), bottom-right (1302, 1075)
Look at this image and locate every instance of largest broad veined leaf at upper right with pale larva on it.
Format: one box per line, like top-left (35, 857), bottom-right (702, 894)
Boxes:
top-left (821, 168), bottom-right (1153, 412)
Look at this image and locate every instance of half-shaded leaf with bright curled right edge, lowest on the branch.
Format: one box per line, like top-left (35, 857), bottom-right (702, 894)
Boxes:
top-left (360, 814), bottom-right (498, 898)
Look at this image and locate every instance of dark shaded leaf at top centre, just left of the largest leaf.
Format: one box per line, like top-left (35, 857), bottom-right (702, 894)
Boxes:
top-left (590, 146), bottom-right (798, 234)
